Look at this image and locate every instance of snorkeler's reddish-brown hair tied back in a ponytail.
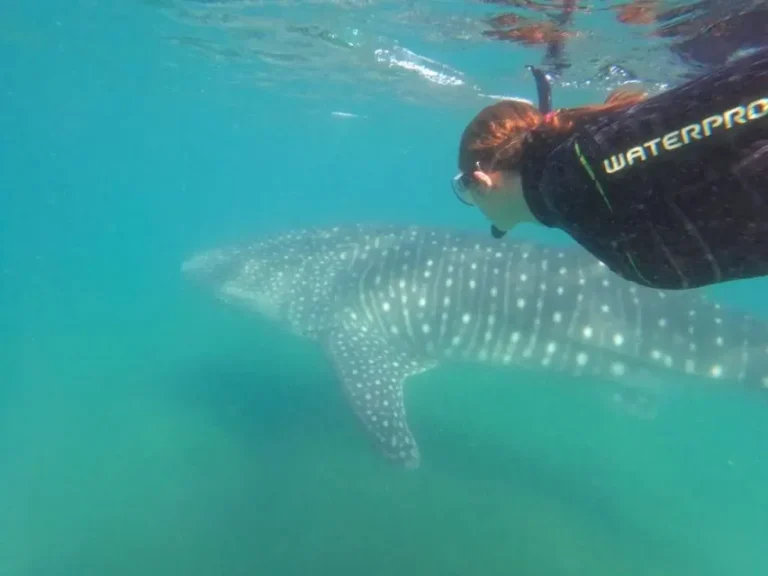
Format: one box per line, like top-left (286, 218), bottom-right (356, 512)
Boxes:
top-left (459, 89), bottom-right (648, 173)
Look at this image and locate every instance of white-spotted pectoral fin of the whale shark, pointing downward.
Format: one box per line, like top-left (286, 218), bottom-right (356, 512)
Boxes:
top-left (325, 326), bottom-right (433, 468)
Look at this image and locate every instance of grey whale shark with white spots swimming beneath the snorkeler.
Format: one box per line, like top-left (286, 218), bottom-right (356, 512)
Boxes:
top-left (181, 224), bottom-right (768, 468)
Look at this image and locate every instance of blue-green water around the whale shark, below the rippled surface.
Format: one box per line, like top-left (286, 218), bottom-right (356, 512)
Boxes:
top-left (0, 1), bottom-right (768, 576)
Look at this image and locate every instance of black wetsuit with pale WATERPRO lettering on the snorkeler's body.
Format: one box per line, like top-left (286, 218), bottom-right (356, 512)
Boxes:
top-left (527, 50), bottom-right (768, 288)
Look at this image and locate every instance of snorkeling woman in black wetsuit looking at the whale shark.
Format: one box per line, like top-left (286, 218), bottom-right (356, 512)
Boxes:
top-left (453, 49), bottom-right (768, 289)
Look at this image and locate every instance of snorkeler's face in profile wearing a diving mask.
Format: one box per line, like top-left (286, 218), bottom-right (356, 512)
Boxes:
top-left (453, 166), bottom-right (532, 232)
